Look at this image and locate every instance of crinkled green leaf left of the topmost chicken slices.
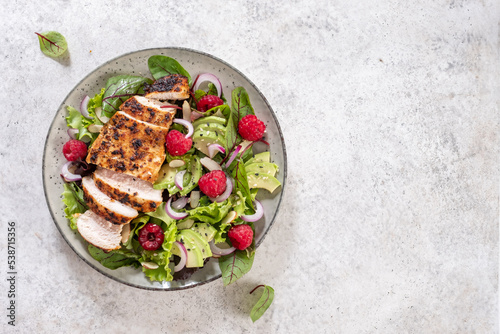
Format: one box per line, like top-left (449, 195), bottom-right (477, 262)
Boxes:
top-left (102, 75), bottom-right (152, 117)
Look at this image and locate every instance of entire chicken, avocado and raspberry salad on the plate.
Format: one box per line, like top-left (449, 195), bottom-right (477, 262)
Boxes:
top-left (61, 55), bottom-right (281, 285)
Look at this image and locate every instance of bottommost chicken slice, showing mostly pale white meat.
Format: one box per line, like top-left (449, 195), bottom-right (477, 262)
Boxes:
top-left (76, 210), bottom-right (123, 251)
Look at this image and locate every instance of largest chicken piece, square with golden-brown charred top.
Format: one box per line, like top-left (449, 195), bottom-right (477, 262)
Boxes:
top-left (87, 111), bottom-right (168, 183)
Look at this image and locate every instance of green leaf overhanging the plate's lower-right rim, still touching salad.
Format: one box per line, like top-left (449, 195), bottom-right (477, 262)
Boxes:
top-left (219, 250), bottom-right (255, 286)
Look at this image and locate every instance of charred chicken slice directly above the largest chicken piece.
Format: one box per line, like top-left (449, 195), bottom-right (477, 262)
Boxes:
top-left (120, 96), bottom-right (175, 128)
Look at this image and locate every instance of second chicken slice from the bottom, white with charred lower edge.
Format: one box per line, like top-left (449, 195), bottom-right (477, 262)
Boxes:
top-left (82, 176), bottom-right (139, 224)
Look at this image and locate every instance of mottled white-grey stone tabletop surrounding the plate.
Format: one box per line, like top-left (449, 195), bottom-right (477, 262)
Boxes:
top-left (0, 0), bottom-right (500, 333)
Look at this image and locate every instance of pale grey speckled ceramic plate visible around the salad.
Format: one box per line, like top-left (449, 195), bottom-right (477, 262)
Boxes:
top-left (43, 48), bottom-right (287, 291)
